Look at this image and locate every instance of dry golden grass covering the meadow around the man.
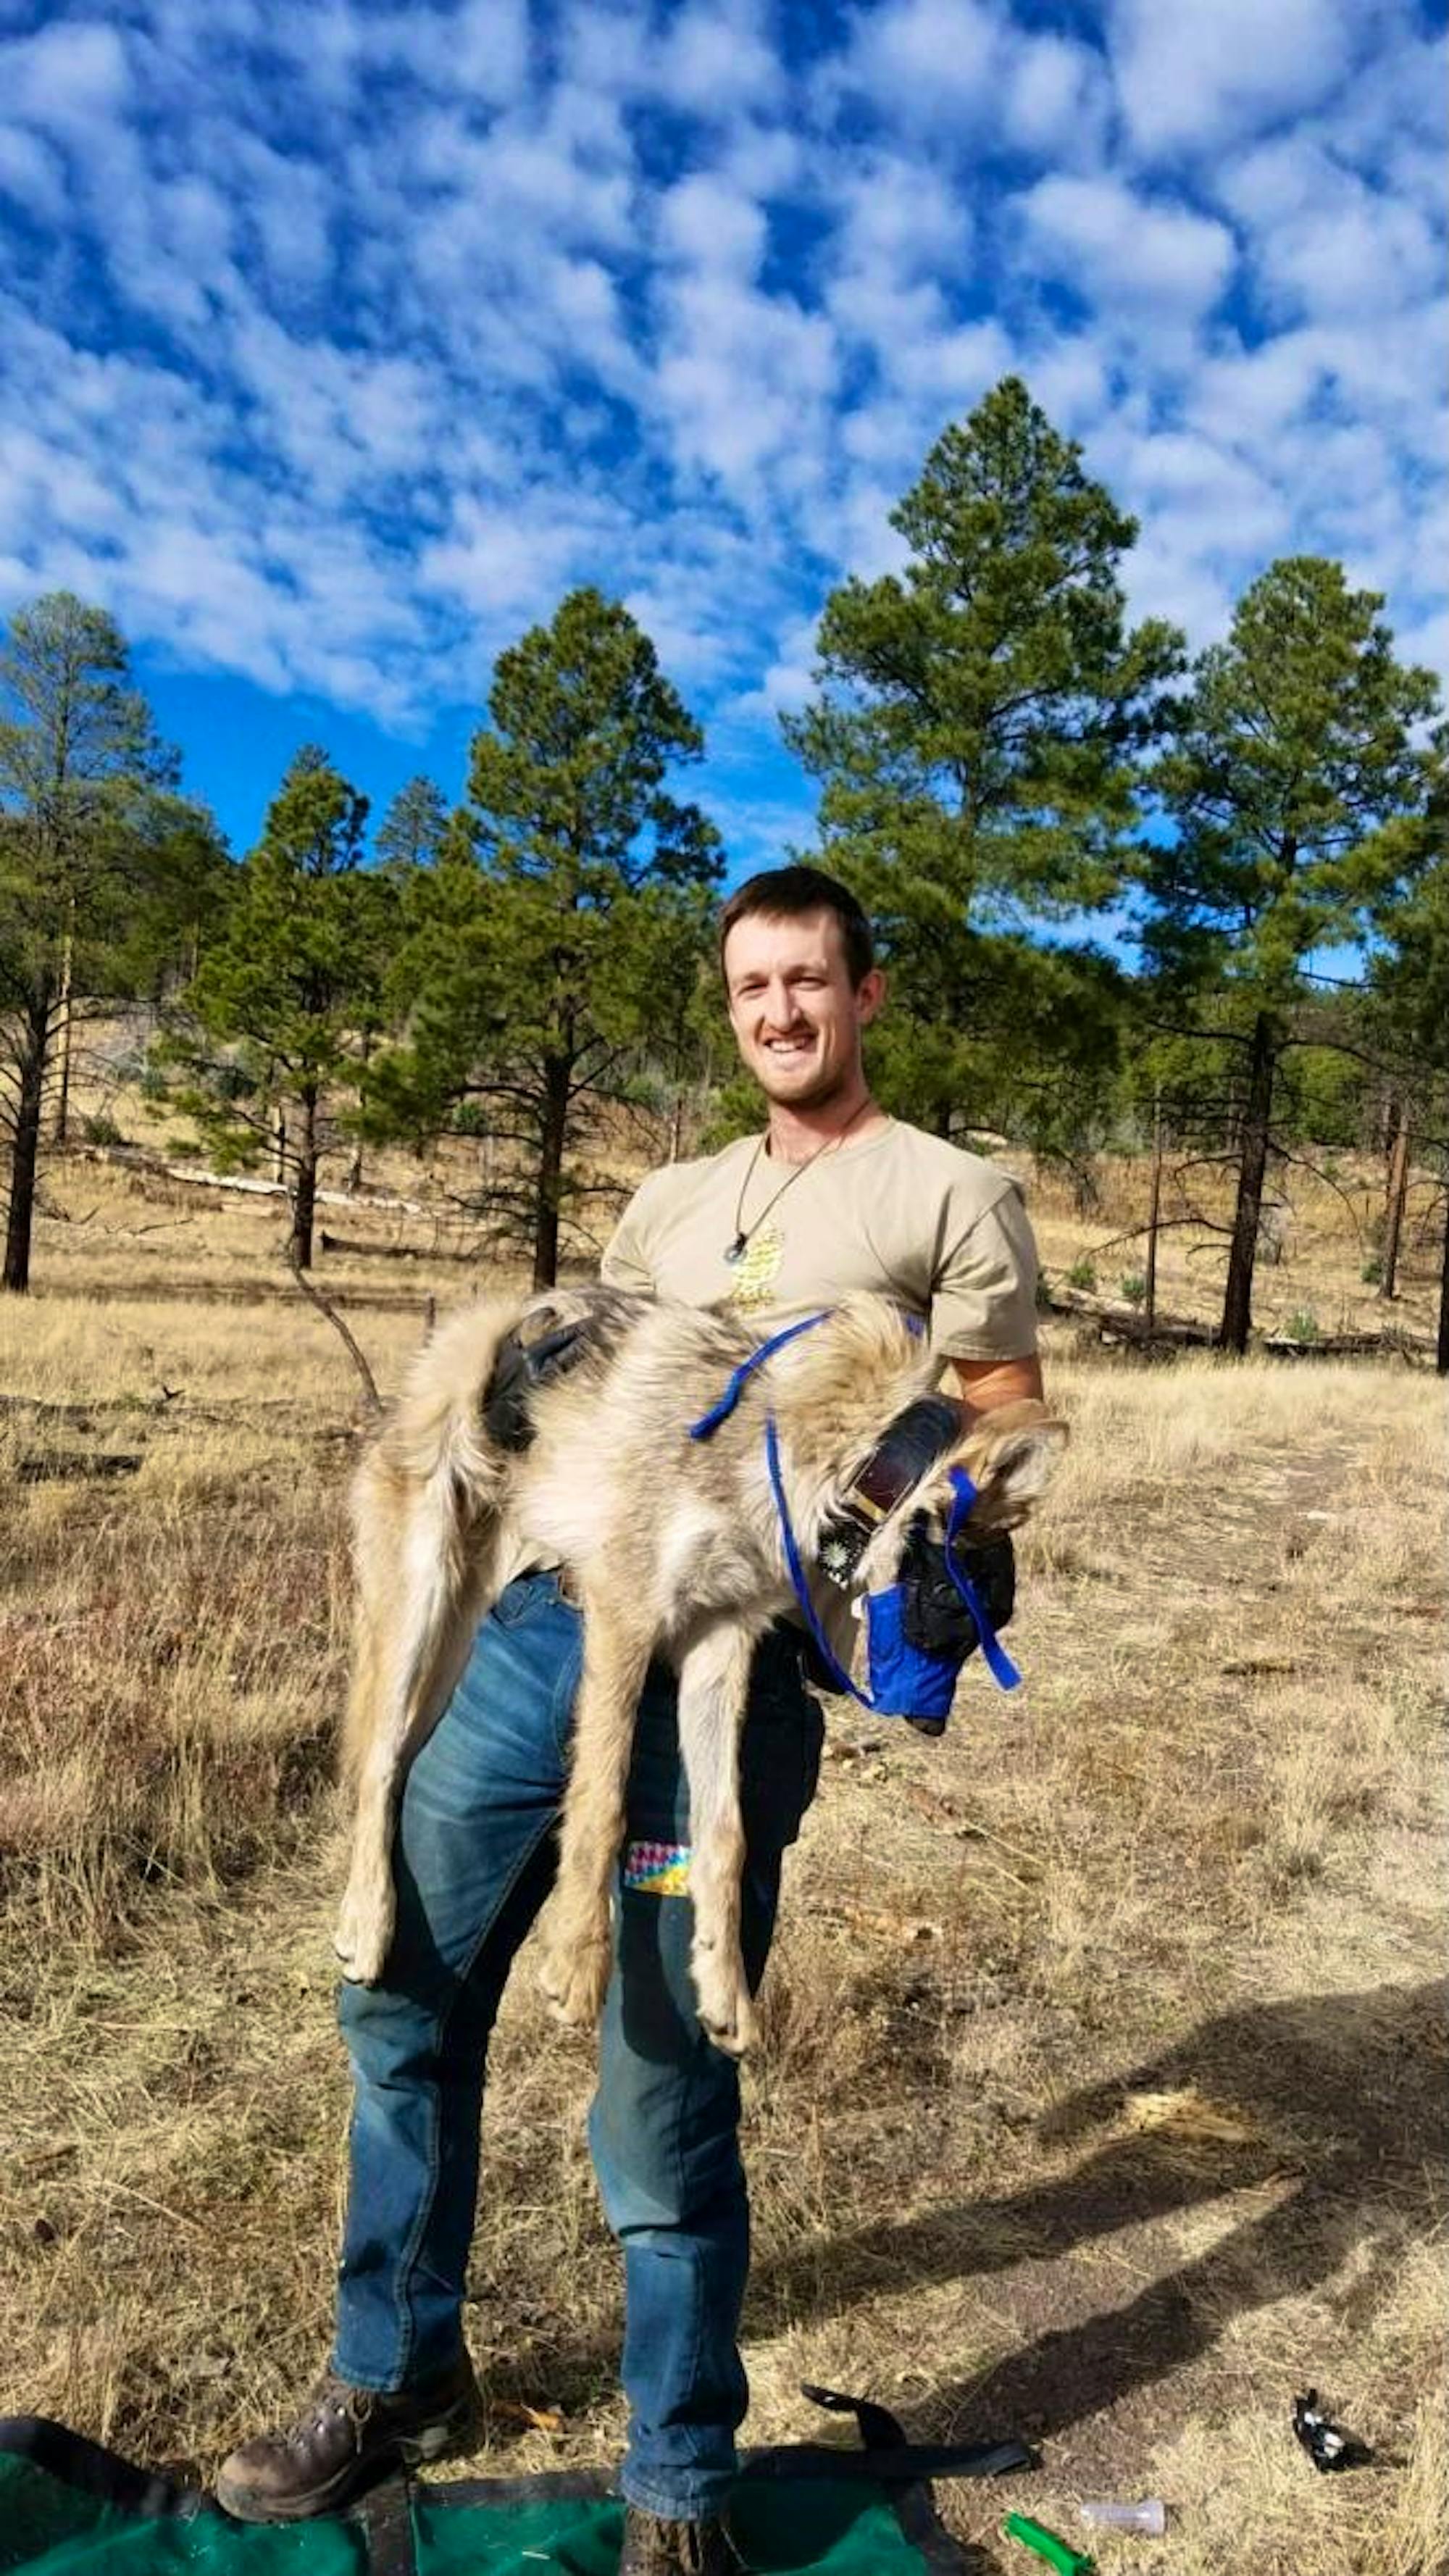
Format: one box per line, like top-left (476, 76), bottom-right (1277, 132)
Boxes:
top-left (0, 1133), bottom-right (1449, 2576)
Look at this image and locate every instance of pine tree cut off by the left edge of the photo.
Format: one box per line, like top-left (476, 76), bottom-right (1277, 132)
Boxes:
top-left (0, 590), bottom-right (222, 1291)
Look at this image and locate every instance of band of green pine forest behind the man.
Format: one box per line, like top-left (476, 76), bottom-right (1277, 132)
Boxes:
top-left (0, 379), bottom-right (1449, 1370)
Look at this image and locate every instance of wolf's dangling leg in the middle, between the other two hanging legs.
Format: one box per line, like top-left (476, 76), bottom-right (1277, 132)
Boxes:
top-left (543, 1592), bottom-right (651, 2025)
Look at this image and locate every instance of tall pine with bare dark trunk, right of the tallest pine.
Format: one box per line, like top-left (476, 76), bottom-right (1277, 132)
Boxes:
top-left (1137, 557), bottom-right (1441, 1352)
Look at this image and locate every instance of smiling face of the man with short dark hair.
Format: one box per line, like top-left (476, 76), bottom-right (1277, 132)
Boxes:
top-left (723, 912), bottom-right (885, 1110)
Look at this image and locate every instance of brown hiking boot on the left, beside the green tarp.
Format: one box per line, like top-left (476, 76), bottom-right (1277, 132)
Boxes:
top-left (216, 2352), bottom-right (484, 2522)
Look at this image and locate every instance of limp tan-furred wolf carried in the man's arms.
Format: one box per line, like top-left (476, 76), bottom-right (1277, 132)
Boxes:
top-left (335, 1291), bottom-right (1066, 2056)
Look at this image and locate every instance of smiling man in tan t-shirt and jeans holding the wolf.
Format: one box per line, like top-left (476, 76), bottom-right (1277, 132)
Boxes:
top-left (216, 868), bottom-right (1043, 2576)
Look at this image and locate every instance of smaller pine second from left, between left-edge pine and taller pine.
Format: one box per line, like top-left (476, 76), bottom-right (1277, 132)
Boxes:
top-left (159, 744), bottom-right (373, 1270)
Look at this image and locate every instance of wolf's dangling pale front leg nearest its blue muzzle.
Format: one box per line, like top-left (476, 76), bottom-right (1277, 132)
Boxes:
top-left (680, 1620), bottom-right (754, 2058)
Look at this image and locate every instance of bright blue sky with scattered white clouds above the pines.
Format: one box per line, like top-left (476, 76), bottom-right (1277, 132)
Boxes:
top-left (0, 0), bottom-right (1449, 871)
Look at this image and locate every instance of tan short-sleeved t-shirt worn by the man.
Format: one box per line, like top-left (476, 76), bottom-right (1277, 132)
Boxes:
top-left (602, 1118), bottom-right (1037, 1360)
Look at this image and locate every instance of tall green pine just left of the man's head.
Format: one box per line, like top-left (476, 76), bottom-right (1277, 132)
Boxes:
top-left (371, 590), bottom-right (721, 1288)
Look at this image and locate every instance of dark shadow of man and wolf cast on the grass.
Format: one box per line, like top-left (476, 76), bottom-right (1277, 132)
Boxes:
top-left (492, 1981), bottom-right (1449, 2440)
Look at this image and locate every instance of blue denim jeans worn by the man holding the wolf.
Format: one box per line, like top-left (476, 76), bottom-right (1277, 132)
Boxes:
top-left (332, 1574), bottom-right (821, 2519)
